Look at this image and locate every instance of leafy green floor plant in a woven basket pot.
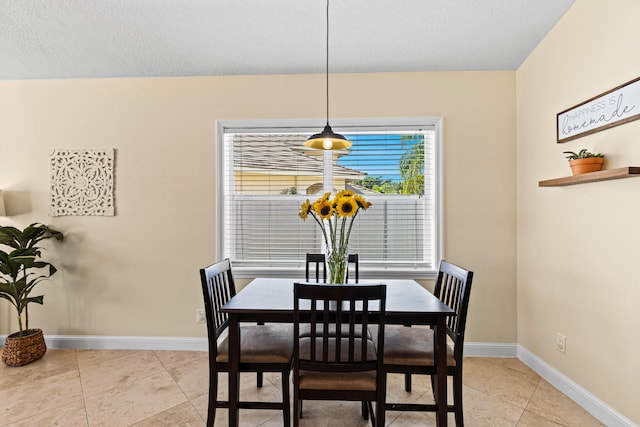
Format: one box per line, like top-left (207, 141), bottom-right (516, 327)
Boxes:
top-left (0, 223), bottom-right (64, 366)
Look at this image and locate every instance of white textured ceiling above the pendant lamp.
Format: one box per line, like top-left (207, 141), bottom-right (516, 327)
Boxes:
top-left (0, 0), bottom-right (575, 80)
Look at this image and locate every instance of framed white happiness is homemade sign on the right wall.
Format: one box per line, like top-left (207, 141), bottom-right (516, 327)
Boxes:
top-left (556, 77), bottom-right (640, 143)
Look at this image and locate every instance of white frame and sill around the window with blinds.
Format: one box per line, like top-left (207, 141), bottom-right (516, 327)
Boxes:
top-left (215, 117), bottom-right (443, 279)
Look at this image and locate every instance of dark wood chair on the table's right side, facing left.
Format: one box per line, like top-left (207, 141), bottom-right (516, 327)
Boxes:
top-left (380, 260), bottom-right (473, 426)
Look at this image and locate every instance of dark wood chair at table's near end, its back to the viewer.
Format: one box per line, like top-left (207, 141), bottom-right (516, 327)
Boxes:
top-left (293, 283), bottom-right (386, 427)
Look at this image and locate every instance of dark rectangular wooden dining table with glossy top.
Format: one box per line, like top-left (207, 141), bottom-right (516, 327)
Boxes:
top-left (221, 278), bottom-right (455, 427)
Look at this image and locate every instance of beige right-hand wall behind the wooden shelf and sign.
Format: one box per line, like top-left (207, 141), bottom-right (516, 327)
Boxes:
top-left (516, 0), bottom-right (640, 423)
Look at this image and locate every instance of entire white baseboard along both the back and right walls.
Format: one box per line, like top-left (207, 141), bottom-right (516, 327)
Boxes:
top-left (0, 335), bottom-right (638, 427)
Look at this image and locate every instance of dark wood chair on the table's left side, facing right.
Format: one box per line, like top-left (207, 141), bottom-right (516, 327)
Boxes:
top-left (200, 259), bottom-right (293, 426)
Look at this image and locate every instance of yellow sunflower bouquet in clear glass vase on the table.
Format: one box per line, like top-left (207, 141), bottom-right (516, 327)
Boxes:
top-left (298, 190), bottom-right (371, 283)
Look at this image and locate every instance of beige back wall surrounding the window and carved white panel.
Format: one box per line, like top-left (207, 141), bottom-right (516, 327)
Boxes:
top-left (0, 72), bottom-right (516, 343)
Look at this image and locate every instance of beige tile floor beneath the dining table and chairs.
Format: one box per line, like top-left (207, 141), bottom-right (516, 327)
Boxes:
top-left (0, 349), bottom-right (602, 427)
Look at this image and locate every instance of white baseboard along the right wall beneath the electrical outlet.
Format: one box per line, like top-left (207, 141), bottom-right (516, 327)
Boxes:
top-left (516, 345), bottom-right (638, 427)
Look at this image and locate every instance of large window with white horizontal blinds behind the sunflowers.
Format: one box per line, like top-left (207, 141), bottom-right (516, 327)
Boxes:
top-left (218, 118), bottom-right (441, 278)
